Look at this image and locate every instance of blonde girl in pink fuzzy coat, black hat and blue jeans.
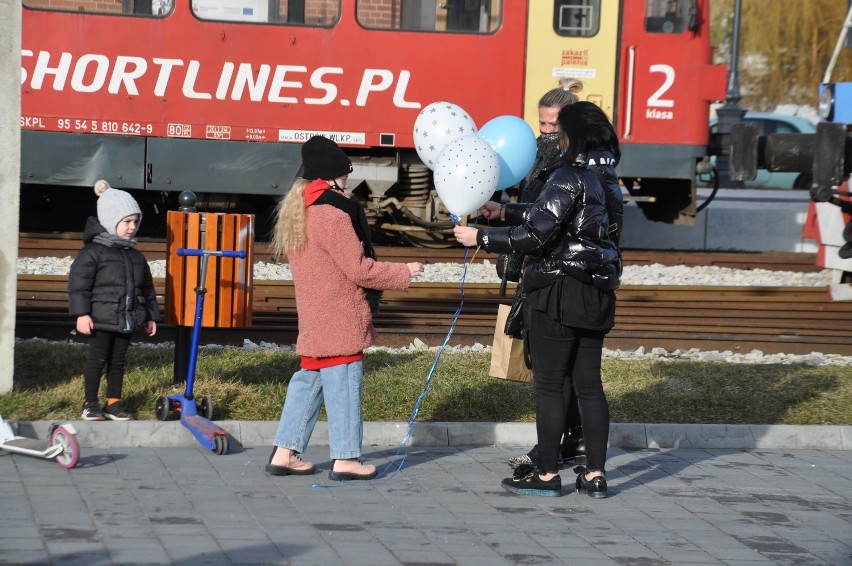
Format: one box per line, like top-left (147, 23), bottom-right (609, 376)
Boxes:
top-left (266, 136), bottom-right (423, 480)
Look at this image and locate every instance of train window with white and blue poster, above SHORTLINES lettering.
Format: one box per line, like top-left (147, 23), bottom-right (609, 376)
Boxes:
top-left (192, 0), bottom-right (340, 27)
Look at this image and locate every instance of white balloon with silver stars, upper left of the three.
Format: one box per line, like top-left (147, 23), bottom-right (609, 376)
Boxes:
top-left (414, 102), bottom-right (476, 170)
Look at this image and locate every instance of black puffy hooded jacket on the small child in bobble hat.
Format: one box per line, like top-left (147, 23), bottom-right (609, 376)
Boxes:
top-left (68, 217), bottom-right (160, 333)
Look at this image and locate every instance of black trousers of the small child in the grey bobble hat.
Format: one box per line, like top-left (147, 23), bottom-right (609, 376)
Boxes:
top-left (83, 330), bottom-right (130, 403)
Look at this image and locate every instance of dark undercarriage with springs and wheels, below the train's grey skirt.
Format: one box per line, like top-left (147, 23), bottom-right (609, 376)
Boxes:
top-left (19, 164), bottom-right (695, 248)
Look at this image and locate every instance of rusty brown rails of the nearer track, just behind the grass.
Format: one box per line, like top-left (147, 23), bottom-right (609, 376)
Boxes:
top-left (16, 276), bottom-right (852, 355)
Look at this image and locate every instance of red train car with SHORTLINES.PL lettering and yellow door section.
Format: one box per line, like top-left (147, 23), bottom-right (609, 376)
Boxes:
top-left (21, 0), bottom-right (725, 245)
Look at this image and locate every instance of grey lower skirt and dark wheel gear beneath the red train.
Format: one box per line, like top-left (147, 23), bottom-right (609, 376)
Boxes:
top-left (20, 131), bottom-right (695, 248)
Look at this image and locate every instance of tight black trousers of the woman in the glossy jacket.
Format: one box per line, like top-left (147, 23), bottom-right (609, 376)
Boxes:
top-left (526, 308), bottom-right (609, 473)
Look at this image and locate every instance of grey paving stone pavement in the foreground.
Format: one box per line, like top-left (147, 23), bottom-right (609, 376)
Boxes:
top-left (0, 423), bottom-right (852, 566)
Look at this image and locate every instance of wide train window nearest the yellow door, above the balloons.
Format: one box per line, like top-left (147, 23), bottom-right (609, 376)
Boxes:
top-left (355, 0), bottom-right (503, 33)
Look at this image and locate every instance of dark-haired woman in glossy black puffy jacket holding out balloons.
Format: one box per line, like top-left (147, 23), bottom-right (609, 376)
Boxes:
top-left (455, 102), bottom-right (624, 497)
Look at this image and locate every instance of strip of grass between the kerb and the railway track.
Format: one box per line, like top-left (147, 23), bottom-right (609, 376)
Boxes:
top-left (0, 340), bottom-right (852, 425)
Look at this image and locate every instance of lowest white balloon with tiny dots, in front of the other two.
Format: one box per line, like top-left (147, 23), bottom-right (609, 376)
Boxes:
top-left (435, 134), bottom-right (500, 217)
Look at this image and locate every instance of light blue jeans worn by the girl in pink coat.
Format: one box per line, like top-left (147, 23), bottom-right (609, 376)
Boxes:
top-left (272, 360), bottom-right (364, 460)
